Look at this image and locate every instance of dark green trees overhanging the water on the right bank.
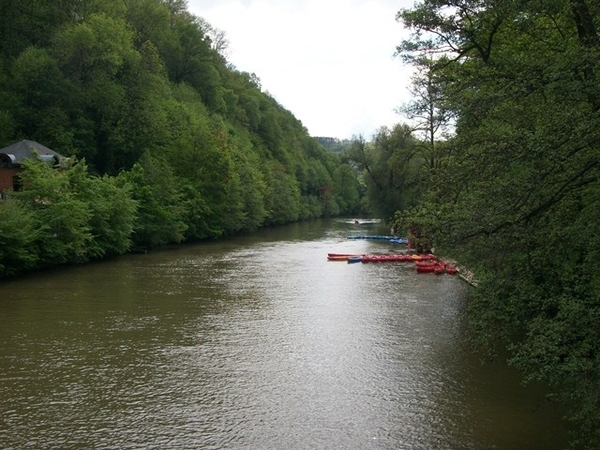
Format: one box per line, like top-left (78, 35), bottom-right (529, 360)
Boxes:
top-left (396, 0), bottom-right (600, 449)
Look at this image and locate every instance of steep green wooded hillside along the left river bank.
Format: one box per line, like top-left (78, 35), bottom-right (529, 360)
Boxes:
top-left (0, 0), bottom-right (360, 275)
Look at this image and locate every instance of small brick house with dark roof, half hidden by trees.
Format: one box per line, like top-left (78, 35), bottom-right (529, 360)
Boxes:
top-left (0, 140), bottom-right (64, 198)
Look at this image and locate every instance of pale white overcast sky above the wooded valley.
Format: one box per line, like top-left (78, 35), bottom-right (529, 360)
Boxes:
top-left (188, 0), bottom-right (414, 140)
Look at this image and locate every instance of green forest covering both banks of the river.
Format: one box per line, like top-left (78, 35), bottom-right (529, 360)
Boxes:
top-left (0, 0), bottom-right (600, 449)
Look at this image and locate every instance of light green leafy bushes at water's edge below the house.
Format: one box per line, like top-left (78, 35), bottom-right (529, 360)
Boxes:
top-left (0, 162), bottom-right (137, 275)
